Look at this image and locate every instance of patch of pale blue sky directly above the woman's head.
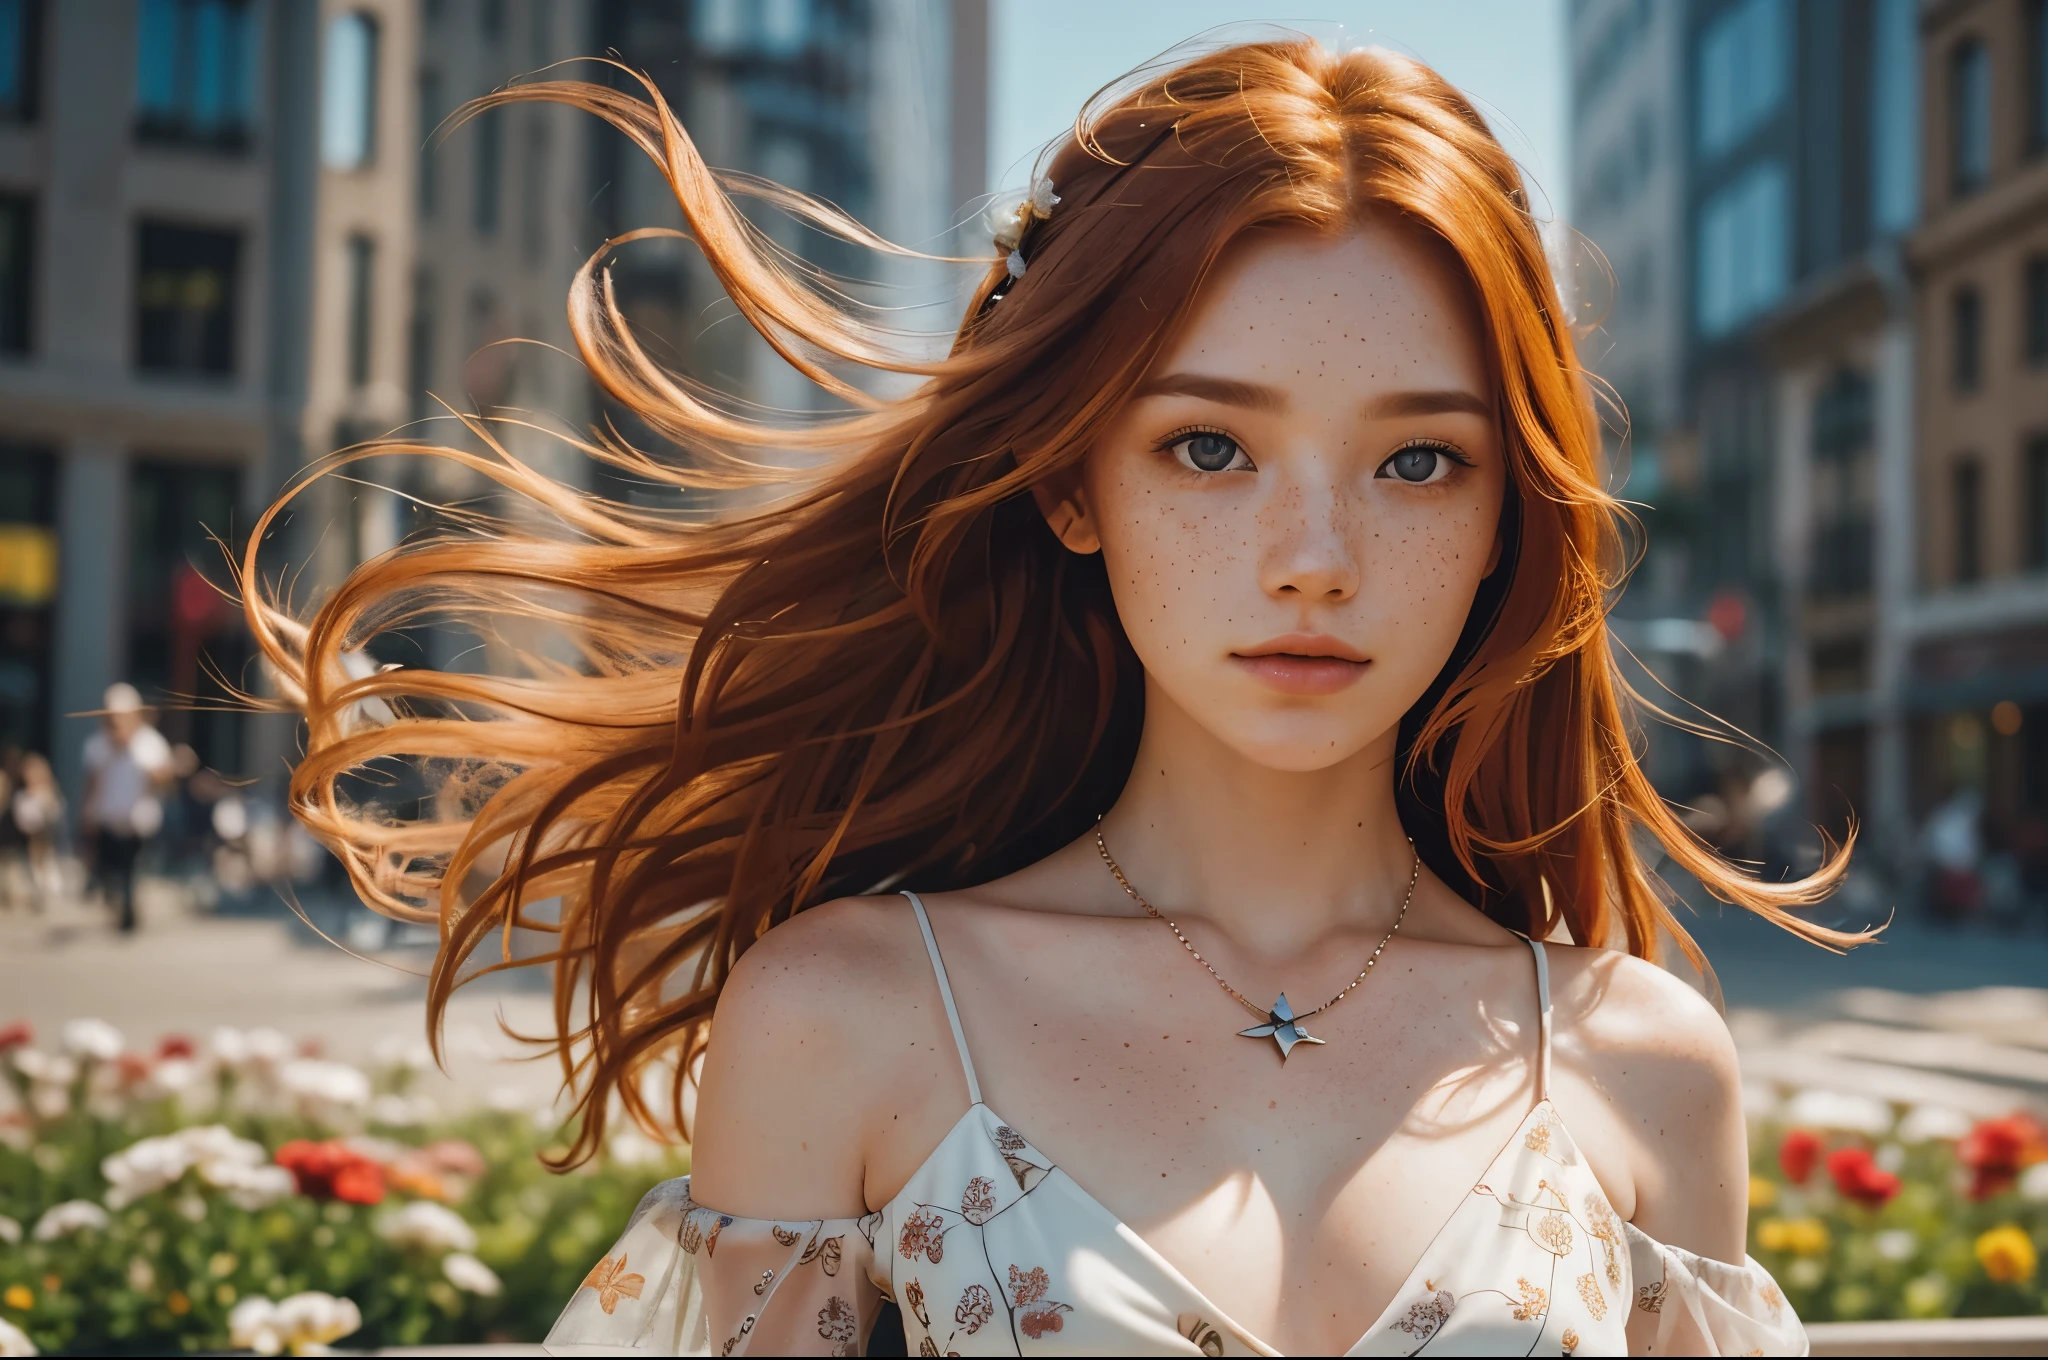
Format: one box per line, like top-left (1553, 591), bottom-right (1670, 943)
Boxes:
top-left (989, 0), bottom-right (1571, 217)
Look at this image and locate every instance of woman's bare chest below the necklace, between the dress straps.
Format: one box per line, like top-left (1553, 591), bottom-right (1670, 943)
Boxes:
top-left (903, 922), bottom-right (1589, 1352)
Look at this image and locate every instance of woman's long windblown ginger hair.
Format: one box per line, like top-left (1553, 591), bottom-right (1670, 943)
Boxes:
top-left (242, 39), bottom-right (1868, 1161)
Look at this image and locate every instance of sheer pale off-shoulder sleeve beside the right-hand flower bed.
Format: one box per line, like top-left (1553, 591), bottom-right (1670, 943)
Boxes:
top-left (1622, 1223), bottom-right (1806, 1356)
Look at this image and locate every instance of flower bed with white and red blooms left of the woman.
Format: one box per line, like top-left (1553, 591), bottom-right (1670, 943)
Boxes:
top-left (0, 1022), bottom-right (684, 1356)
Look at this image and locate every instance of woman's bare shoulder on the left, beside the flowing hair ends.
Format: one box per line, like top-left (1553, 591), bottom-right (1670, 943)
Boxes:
top-left (692, 897), bottom-right (958, 1219)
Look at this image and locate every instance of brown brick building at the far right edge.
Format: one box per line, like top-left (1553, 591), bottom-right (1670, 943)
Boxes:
top-left (1901, 0), bottom-right (2048, 860)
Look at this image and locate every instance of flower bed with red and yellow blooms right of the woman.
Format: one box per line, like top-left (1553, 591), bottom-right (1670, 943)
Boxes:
top-left (1749, 1092), bottom-right (2048, 1321)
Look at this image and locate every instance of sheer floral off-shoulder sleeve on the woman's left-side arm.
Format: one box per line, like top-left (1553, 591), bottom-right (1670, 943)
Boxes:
top-left (543, 1176), bottom-right (879, 1356)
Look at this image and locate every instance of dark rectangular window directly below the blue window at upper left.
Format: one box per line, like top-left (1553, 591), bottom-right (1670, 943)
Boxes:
top-left (135, 221), bottom-right (242, 375)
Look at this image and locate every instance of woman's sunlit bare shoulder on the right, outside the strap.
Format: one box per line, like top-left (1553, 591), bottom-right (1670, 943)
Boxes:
top-left (1550, 946), bottom-right (1749, 1262)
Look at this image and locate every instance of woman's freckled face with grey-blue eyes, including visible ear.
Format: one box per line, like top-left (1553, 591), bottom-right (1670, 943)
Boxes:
top-left (1040, 223), bottom-right (1505, 770)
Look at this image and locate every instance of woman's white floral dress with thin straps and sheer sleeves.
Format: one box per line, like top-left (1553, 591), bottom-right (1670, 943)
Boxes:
top-left (547, 893), bottom-right (1806, 1356)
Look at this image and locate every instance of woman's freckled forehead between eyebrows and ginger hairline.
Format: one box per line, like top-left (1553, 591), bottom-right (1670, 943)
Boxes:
top-left (1157, 219), bottom-right (1487, 397)
